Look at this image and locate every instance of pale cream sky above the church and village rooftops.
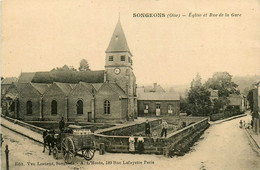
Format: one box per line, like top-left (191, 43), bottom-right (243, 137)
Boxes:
top-left (1, 0), bottom-right (260, 85)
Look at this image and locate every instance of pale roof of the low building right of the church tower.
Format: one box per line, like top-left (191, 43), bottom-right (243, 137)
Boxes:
top-left (137, 92), bottom-right (180, 100)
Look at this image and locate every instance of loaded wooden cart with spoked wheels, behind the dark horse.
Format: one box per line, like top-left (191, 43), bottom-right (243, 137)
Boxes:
top-left (53, 125), bottom-right (95, 163)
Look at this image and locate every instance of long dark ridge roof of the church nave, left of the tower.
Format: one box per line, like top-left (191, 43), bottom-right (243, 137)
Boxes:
top-left (32, 70), bottom-right (104, 84)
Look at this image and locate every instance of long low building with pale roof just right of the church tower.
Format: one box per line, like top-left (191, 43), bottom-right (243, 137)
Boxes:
top-left (137, 87), bottom-right (180, 116)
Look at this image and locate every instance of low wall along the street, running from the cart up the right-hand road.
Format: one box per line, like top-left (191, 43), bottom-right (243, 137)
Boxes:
top-left (95, 118), bottom-right (209, 154)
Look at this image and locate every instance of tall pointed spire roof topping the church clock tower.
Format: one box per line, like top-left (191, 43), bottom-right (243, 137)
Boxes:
top-left (106, 19), bottom-right (132, 55)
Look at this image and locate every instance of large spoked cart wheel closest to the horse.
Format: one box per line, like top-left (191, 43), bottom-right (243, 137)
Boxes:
top-left (61, 137), bottom-right (75, 164)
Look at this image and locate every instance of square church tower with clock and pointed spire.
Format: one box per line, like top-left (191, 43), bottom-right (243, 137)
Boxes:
top-left (105, 19), bottom-right (137, 120)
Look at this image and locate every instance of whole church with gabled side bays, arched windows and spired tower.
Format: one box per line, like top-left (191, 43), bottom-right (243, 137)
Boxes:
top-left (3, 20), bottom-right (137, 123)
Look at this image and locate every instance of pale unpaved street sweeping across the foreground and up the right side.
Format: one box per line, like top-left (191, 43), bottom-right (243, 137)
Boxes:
top-left (1, 116), bottom-right (260, 170)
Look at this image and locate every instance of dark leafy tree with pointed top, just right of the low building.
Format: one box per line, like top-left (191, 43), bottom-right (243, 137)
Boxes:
top-left (187, 74), bottom-right (211, 116)
